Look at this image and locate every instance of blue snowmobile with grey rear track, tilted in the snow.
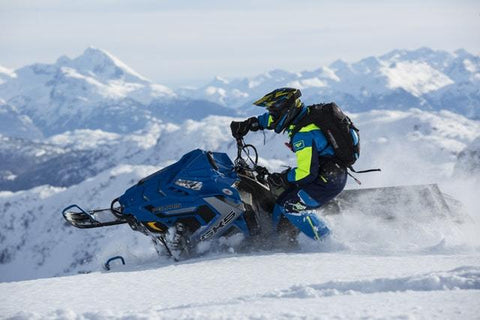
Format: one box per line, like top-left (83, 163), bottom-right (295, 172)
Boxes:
top-left (62, 139), bottom-right (467, 260)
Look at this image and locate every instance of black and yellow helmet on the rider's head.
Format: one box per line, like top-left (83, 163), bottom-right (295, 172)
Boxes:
top-left (253, 88), bottom-right (303, 133)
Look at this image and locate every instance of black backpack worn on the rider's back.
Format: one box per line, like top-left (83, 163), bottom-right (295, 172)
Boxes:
top-left (291, 102), bottom-right (380, 178)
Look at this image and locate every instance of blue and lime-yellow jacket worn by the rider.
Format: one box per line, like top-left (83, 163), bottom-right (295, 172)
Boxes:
top-left (257, 107), bottom-right (334, 184)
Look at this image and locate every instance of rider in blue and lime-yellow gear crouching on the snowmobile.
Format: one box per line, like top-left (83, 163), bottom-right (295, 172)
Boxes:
top-left (230, 88), bottom-right (347, 241)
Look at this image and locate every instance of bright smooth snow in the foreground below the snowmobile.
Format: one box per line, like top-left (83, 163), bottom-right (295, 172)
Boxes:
top-left (0, 253), bottom-right (480, 319)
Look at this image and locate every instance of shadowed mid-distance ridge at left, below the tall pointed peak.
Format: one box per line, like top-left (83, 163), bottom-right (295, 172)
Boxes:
top-left (0, 123), bottom-right (165, 191)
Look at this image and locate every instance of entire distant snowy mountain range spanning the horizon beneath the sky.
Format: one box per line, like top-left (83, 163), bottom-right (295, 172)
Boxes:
top-left (0, 47), bottom-right (480, 137)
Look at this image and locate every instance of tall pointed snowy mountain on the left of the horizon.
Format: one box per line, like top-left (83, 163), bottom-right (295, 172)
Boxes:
top-left (0, 47), bottom-right (233, 136)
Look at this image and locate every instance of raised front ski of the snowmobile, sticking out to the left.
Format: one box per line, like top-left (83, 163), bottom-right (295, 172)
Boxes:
top-left (62, 204), bottom-right (128, 229)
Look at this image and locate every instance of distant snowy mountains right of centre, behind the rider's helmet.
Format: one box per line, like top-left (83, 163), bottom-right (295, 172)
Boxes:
top-left (184, 48), bottom-right (480, 119)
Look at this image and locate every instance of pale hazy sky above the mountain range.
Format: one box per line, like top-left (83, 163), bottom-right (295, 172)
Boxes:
top-left (0, 0), bottom-right (480, 87)
